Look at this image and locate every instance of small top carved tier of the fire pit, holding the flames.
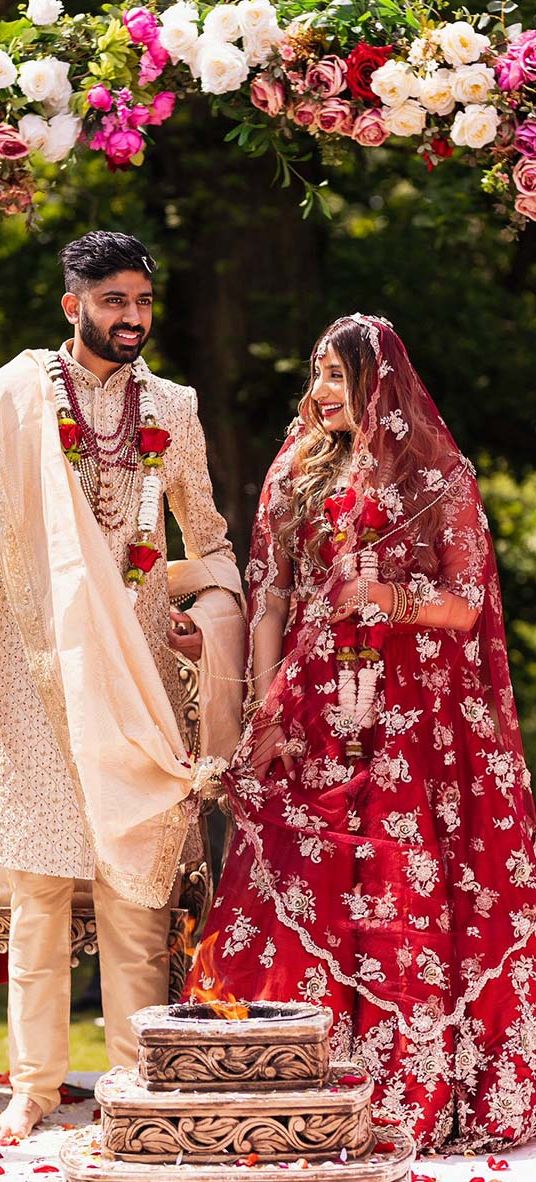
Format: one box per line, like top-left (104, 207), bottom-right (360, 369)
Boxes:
top-left (131, 1001), bottom-right (331, 1092)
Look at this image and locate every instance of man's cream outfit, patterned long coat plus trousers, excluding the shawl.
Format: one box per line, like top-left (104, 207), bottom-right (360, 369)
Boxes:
top-left (0, 345), bottom-right (243, 1111)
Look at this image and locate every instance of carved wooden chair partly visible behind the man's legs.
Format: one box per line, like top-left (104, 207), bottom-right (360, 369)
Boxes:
top-left (0, 660), bottom-right (212, 1002)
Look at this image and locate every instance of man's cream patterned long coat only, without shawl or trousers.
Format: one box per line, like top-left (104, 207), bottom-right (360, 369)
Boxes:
top-left (0, 345), bottom-right (232, 878)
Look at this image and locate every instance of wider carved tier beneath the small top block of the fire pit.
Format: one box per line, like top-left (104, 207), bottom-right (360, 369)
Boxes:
top-left (95, 1064), bottom-right (373, 1164)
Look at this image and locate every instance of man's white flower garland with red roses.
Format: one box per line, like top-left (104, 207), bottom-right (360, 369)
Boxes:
top-left (45, 352), bottom-right (172, 603)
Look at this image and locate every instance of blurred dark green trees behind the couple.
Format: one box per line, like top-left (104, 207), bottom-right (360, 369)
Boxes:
top-left (0, 0), bottom-right (536, 767)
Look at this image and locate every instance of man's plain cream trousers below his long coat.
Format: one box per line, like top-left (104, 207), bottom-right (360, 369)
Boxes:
top-left (7, 870), bottom-right (169, 1116)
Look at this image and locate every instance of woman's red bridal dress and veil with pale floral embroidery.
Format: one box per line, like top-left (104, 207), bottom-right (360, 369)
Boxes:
top-left (187, 318), bottom-right (536, 1149)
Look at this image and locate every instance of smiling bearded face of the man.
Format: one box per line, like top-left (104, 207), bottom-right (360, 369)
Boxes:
top-left (65, 271), bottom-right (153, 363)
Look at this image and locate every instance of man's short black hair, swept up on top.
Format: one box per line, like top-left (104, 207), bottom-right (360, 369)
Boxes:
top-left (58, 229), bottom-right (157, 294)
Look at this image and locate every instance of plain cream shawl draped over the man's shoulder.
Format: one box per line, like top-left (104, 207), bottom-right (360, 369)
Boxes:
top-left (0, 351), bottom-right (195, 907)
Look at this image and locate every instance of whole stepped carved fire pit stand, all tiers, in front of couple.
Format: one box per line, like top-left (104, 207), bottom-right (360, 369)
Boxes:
top-left (62, 1002), bottom-right (414, 1182)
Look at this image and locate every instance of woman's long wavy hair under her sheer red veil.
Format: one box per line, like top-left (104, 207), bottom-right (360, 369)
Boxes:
top-left (278, 317), bottom-right (449, 573)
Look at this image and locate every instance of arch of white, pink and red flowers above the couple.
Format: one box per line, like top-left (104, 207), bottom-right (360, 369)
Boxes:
top-left (0, 0), bottom-right (536, 228)
